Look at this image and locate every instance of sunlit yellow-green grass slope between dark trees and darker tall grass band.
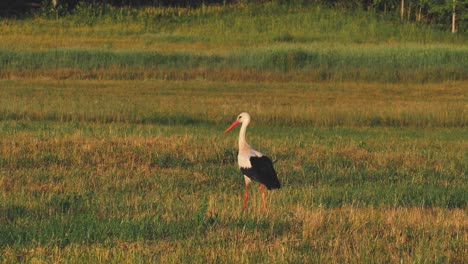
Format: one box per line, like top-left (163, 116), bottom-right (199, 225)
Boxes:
top-left (0, 4), bottom-right (468, 51)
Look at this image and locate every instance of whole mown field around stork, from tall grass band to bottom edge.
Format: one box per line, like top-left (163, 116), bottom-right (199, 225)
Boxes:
top-left (0, 80), bottom-right (468, 262)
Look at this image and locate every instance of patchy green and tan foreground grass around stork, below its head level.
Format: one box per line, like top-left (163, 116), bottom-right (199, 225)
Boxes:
top-left (0, 121), bottom-right (467, 262)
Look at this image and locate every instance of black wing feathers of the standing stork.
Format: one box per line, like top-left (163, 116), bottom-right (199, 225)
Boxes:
top-left (241, 156), bottom-right (281, 190)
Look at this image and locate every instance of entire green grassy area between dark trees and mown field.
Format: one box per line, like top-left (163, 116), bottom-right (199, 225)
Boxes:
top-left (0, 5), bottom-right (468, 82)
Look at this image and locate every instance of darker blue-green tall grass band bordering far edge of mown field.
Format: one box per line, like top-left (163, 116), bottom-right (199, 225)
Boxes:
top-left (0, 45), bottom-right (468, 82)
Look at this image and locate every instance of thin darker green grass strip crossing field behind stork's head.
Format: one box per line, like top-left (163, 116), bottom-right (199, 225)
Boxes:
top-left (0, 111), bottom-right (467, 128)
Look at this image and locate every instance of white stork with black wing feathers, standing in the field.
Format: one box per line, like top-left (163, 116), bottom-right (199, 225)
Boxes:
top-left (224, 112), bottom-right (281, 211)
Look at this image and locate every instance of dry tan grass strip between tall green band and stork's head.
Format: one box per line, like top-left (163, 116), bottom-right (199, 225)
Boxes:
top-left (0, 80), bottom-right (468, 127)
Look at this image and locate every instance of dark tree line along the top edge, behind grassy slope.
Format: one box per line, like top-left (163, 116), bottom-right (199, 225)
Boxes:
top-left (0, 0), bottom-right (468, 32)
